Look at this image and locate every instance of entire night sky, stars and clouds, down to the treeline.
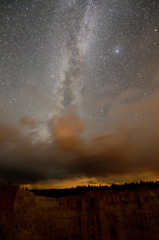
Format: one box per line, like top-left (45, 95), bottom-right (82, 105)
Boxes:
top-left (0, 0), bottom-right (159, 187)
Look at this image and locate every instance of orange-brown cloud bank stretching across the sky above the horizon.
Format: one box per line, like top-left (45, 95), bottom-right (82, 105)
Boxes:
top-left (0, 92), bottom-right (159, 184)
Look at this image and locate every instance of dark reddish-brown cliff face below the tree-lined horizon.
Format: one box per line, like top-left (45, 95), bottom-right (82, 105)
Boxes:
top-left (0, 183), bottom-right (159, 240)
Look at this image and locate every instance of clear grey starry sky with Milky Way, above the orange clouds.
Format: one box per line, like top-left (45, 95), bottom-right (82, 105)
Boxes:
top-left (0, 1), bottom-right (159, 122)
